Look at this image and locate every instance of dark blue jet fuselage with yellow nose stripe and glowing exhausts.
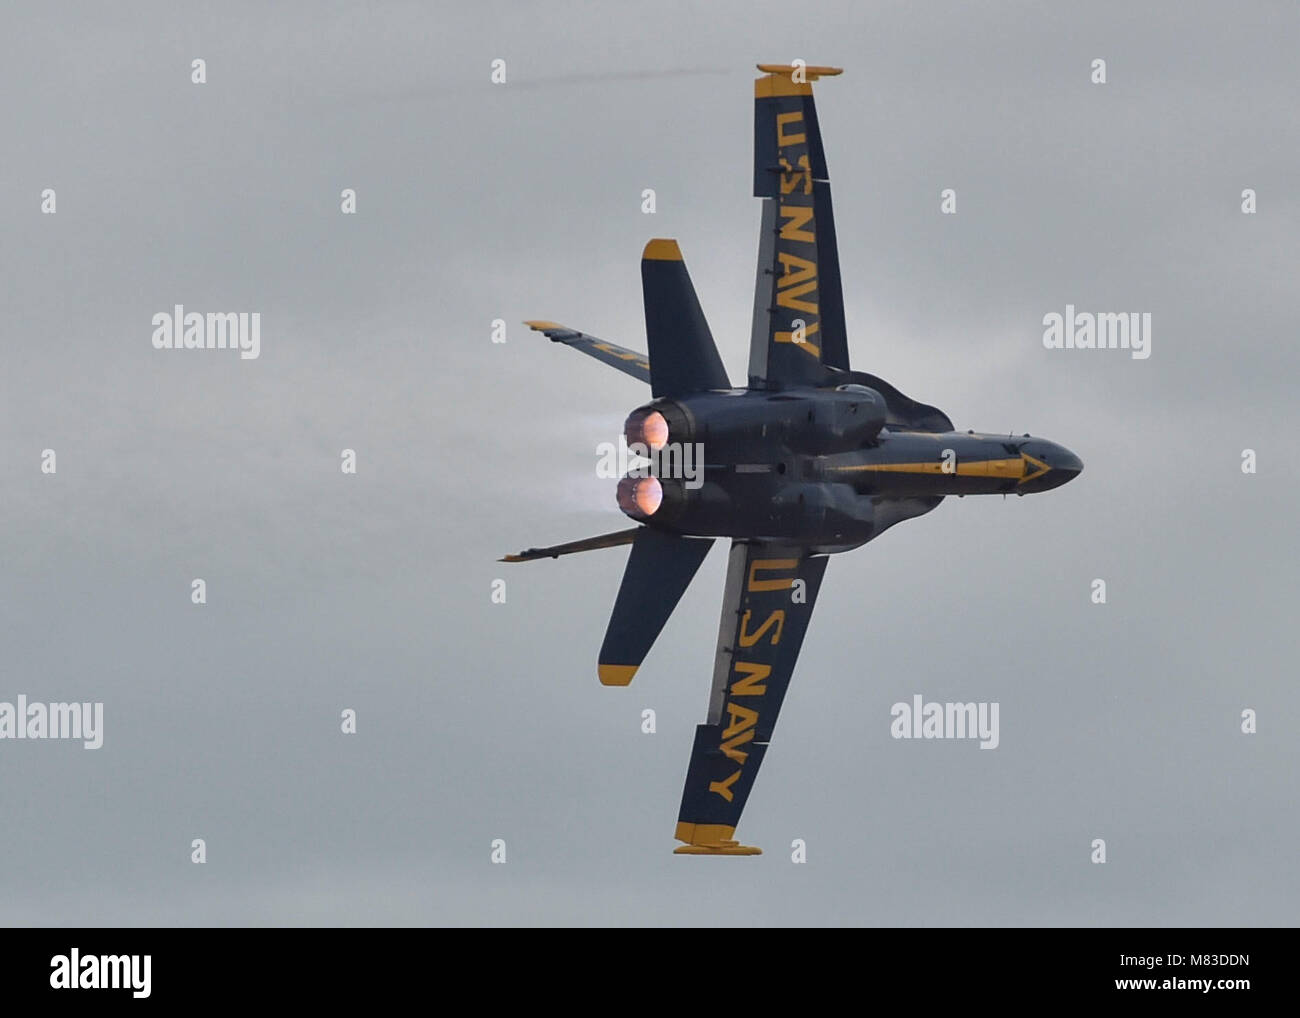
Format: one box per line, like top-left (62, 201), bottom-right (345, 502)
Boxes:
top-left (619, 373), bottom-right (1083, 550)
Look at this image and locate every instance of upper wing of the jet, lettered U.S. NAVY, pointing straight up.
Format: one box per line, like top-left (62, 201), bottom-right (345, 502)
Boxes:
top-left (749, 64), bottom-right (849, 389)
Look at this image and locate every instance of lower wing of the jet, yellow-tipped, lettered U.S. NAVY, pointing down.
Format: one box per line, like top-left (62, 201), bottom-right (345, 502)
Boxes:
top-left (676, 541), bottom-right (827, 855)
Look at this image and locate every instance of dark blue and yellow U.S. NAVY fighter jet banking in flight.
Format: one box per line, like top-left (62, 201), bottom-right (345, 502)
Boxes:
top-left (503, 64), bottom-right (1083, 855)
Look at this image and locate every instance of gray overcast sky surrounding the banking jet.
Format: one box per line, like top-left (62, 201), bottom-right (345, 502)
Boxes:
top-left (0, 3), bottom-right (1300, 926)
